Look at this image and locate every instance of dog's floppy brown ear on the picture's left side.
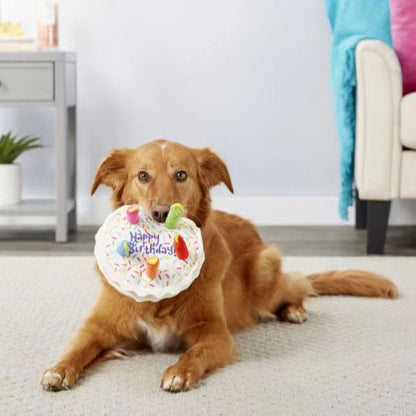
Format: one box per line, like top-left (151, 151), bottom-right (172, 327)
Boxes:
top-left (91, 149), bottom-right (128, 195)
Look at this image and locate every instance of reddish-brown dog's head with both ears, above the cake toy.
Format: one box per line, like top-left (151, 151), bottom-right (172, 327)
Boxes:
top-left (91, 140), bottom-right (233, 226)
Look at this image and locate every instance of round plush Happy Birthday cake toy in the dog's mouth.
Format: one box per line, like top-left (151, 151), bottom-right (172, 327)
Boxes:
top-left (94, 204), bottom-right (205, 302)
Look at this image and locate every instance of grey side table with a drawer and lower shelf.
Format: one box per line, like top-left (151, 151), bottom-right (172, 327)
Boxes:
top-left (0, 50), bottom-right (77, 242)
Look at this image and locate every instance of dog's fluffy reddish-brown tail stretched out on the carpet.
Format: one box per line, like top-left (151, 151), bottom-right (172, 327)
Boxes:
top-left (306, 270), bottom-right (398, 299)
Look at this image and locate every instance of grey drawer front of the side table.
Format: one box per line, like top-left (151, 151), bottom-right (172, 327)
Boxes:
top-left (0, 62), bottom-right (54, 102)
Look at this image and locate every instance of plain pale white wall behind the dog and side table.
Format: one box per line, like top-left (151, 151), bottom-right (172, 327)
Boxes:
top-left (0, 0), bottom-right (416, 222)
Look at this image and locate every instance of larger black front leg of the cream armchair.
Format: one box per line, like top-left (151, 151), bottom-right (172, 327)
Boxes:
top-left (367, 201), bottom-right (391, 254)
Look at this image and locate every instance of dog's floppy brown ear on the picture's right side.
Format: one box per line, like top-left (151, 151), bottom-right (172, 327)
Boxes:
top-left (195, 147), bottom-right (234, 193)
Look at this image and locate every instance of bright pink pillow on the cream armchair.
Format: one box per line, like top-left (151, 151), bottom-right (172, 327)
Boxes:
top-left (390, 0), bottom-right (416, 94)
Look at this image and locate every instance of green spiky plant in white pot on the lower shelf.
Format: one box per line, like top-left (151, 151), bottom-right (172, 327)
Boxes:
top-left (0, 131), bottom-right (42, 206)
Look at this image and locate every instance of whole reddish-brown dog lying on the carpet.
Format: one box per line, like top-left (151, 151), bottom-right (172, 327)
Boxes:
top-left (42, 140), bottom-right (397, 391)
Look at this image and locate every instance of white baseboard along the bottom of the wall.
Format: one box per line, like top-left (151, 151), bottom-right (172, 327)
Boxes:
top-left (0, 195), bottom-right (416, 226)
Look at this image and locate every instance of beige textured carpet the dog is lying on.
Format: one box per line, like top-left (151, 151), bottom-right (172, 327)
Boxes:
top-left (0, 257), bottom-right (416, 416)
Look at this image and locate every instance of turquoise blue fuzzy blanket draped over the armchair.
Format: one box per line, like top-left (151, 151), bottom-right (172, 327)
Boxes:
top-left (325, 0), bottom-right (391, 219)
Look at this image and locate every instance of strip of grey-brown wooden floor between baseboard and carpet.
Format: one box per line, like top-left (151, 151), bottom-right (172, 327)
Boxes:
top-left (0, 226), bottom-right (416, 256)
